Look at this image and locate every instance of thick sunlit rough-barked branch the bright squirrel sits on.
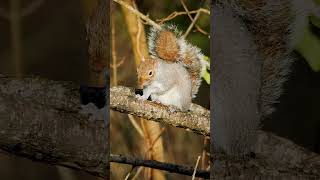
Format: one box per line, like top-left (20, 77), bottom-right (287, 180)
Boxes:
top-left (110, 86), bottom-right (210, 136)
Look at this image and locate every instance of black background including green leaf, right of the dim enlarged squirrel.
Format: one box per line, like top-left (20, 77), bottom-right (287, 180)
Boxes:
top-left (263, 4), bottom-right (320, 154)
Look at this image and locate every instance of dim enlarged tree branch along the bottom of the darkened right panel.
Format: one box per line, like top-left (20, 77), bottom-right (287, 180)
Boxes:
top-left (210, 131), bottom-right (320, 179)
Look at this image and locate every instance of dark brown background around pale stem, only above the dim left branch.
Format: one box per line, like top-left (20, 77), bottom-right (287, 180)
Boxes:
top-left (0, 0), bottom-right (88, 83)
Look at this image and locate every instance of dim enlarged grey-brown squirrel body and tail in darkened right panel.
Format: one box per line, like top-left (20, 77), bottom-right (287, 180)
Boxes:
top-left (210, 0), bottom-right (319, 157)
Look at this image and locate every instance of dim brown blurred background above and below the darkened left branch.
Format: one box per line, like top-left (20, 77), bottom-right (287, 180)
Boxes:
top-left (0, 0), bottom-right (101, 180)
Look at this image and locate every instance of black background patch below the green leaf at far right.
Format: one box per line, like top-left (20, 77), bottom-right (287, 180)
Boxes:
top-left (263, 53), bottom-right (320, 153)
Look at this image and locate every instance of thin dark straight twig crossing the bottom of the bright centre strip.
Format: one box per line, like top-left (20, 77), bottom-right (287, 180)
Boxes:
top-left (110, 154), bottom-right (210, 179)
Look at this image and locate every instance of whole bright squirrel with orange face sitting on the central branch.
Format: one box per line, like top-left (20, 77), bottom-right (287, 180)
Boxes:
top-left (137, 24), bottom-right (205, 111)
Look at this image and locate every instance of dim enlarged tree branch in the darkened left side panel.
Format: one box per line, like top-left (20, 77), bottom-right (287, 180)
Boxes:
top-left (0, 76), bottom-right (109, 176)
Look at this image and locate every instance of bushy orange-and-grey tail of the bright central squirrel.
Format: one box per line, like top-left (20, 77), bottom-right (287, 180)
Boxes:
top-left (148, 25), bottom-right (204, 97)
